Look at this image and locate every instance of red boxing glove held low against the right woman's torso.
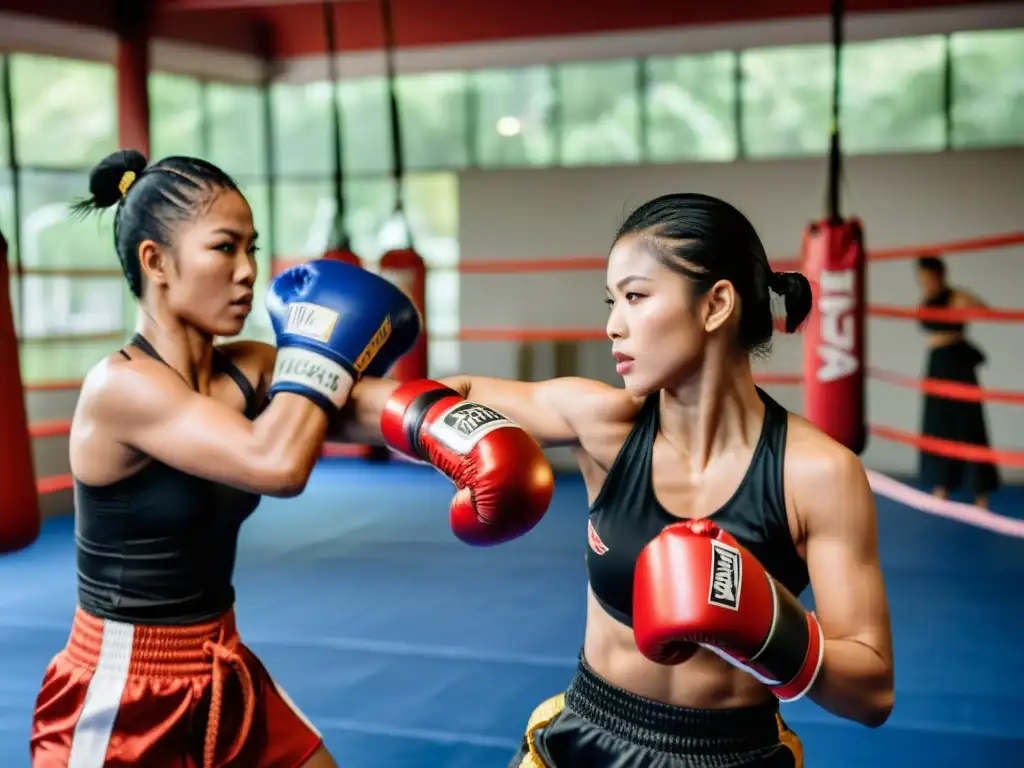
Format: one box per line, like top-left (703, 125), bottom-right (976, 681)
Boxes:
top-left (633, 520), bottom-right (824, 701)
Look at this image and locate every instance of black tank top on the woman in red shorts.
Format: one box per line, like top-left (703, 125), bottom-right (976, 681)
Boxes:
top-left (75, 334), bottom-right (260, 625)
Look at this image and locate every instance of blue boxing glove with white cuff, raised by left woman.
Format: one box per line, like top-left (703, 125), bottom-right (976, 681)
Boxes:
top-left (266, 259), bottom-right (422, 416)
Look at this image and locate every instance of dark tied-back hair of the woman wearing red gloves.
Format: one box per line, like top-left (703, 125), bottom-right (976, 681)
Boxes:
top-left (615, 193), bottom-right (811, 353)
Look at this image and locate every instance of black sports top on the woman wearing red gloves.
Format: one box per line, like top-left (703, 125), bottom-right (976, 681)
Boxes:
top-left (587, 389), bottom-right (810, 626)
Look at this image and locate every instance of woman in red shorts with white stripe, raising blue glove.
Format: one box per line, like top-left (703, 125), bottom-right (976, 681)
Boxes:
top-left (31, 152), bottom-right (420, 768)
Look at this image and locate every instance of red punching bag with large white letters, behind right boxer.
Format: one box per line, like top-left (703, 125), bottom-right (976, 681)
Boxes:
top-left (801, 219), bottom-right (867, 454)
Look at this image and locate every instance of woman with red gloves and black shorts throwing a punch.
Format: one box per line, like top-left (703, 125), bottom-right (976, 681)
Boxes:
top-left (346, 195), bottom-right (893, 768)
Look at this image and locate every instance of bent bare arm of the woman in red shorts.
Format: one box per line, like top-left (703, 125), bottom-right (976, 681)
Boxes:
top-left (91, 360), bottom-right (327, 496)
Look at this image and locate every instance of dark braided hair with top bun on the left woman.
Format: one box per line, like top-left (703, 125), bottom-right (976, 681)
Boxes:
top-left (72, 150), bottom-right (239, 298)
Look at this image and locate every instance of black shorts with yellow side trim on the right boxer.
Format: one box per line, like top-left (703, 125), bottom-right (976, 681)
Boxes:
top-left (508, 657), bottom-right (803, 768)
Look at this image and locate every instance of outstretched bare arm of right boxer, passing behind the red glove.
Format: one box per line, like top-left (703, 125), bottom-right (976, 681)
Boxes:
top-left (331, 376), bottom-right (636, 446)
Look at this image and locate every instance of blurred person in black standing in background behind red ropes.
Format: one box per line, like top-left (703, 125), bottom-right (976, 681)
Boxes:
top-left (918, 256), bottom-right (999, 507)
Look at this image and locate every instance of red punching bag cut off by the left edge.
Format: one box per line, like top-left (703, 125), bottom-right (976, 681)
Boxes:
top-left (0, 233), bottom-right (40, 552)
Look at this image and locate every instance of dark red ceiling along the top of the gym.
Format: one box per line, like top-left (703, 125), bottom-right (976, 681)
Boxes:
top-left (0, 0), bottom-right (1017, 59)
